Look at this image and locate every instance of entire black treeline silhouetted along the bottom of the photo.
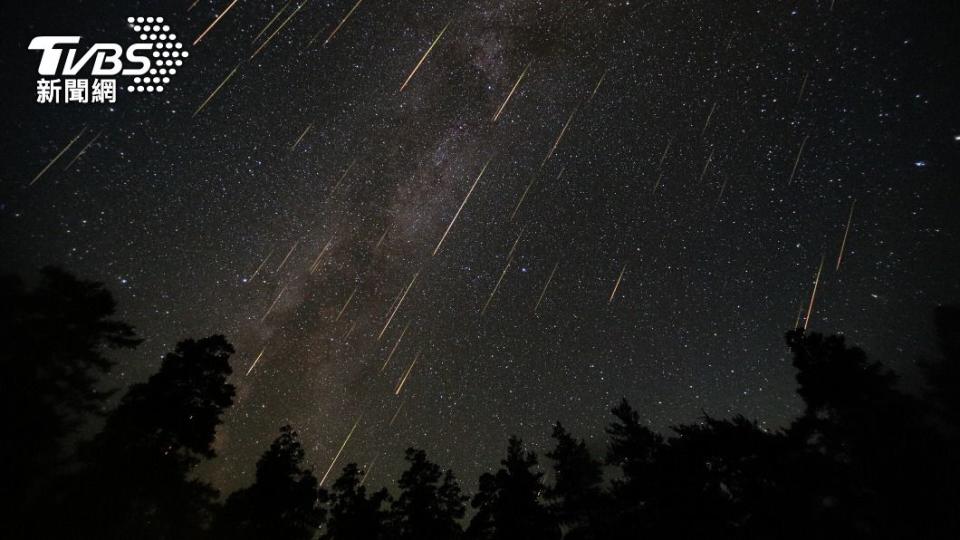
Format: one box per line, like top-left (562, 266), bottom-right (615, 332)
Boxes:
top-left (0, 268), bottom-right (960, 540)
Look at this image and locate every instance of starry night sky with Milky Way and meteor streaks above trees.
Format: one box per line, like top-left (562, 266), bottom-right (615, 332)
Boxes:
top-left (0, 0), bottom-right (960, 496)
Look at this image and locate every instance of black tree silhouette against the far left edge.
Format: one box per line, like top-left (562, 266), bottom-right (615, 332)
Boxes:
top-left (0, 267), bottom-right (140, 538)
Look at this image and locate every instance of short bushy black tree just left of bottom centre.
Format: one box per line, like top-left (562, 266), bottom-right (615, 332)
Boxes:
top-left (392, 448), bottom-right (469, 540)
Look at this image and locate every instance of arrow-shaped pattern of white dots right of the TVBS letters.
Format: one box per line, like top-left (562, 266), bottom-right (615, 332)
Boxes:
top-left (127, 17), bottom-right (190, 92)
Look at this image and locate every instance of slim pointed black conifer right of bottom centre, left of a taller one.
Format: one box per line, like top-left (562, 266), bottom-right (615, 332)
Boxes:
top-left (546, 422), bottom-right (606, 540)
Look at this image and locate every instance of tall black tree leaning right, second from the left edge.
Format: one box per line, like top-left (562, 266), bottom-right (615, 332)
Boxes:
top-left (64, 336), bottom-right (234, 539)
